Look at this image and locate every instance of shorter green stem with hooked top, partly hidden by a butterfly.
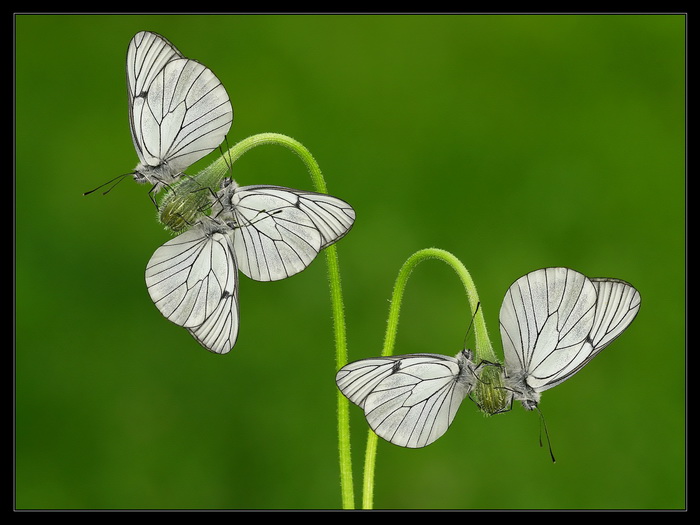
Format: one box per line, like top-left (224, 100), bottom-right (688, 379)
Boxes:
top-left (362, 248), bottom-right (496, 509)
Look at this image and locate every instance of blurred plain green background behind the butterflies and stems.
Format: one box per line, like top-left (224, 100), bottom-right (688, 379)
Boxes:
top-left (15, 15), bottom-right (686, 509)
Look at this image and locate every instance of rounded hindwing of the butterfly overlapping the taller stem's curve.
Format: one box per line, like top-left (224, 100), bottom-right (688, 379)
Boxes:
top-left (230, 186), bottom-right (322, 281)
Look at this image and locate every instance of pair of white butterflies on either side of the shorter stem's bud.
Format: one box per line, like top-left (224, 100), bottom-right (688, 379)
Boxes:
top-left (336, 268), bottom-right (641, 448)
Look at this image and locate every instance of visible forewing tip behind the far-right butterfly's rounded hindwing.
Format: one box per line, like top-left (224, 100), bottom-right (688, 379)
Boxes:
top-left (590, 278), bottom-right (642, 355)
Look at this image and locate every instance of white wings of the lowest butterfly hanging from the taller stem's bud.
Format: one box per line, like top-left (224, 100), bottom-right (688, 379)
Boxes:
top-left (146, 225), bottom-right (238, 353)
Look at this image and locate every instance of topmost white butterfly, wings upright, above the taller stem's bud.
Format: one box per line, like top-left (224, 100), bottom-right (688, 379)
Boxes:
top-left (126, 31), bottom-right (233, 199)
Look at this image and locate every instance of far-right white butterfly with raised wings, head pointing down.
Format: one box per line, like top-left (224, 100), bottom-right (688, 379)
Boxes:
top-left (499, 268), bottom-right (641, 410)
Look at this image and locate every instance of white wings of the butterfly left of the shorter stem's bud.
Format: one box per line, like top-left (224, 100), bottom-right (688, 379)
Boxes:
top-left (336, 354), bottom-right (473, 448)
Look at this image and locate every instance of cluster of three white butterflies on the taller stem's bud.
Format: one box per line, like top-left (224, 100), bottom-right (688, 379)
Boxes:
top-left (120, 31), bottom-right (355, 353)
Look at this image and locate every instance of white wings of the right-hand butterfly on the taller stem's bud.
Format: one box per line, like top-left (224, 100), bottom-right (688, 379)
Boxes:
top-left (226, 186), bottom-right (355, 281)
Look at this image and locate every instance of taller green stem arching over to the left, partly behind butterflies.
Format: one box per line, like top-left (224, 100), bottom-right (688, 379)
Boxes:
top-left (211, 133), bottom-right (355, 509)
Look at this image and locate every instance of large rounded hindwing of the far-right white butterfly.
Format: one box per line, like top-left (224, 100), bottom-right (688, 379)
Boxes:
top-left (499, 268), bottom-right (597, 392)
